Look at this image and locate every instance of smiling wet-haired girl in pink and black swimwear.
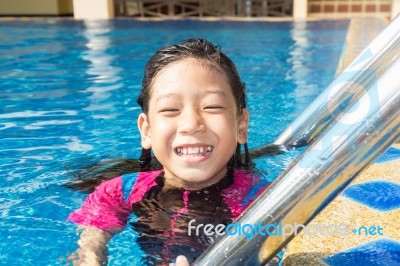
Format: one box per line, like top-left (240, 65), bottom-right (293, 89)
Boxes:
top-left (68, 39), bottom-right (266, 265)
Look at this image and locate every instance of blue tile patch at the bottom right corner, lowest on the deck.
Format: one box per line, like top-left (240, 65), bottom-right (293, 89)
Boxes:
top-left (322, 238), bottom-right (400, 266)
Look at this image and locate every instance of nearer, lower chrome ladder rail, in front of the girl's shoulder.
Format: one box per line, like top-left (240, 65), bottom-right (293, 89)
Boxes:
top-left (195, 17), bottom-right (400, 266)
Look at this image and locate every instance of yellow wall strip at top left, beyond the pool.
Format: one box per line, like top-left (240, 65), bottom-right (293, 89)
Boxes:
top-left (0, 0), bottom-right (73, 15)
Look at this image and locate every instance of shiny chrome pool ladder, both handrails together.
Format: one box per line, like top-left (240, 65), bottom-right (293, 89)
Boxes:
top-left (195, 16), bottom-right (400, 266)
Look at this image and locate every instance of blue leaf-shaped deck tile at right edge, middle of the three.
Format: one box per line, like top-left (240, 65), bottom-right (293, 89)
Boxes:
top-left (342, 181), bottom-right (400, 211)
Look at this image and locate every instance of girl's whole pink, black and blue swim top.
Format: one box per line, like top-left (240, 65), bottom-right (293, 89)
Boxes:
top-left (68, 169), bottom-right (266, 264)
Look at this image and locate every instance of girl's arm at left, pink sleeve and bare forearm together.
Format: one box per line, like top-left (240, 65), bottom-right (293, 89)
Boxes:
top-left (68, 178), bottom-right (130, 265)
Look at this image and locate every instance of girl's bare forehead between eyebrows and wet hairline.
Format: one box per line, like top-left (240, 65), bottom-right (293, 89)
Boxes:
top-left (151, 58), bottom-right (233, 98)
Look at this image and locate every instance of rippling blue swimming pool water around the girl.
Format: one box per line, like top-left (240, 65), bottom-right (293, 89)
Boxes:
top-left (0, 19), bottom-right (348, 265)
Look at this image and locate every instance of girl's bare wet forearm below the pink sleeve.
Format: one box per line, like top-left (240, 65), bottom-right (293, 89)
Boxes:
top-left (69, 226), bottom-right (112, 266)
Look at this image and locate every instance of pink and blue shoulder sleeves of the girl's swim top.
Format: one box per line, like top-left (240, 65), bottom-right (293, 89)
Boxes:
top-left (68, 169), bottom-right (260, 231)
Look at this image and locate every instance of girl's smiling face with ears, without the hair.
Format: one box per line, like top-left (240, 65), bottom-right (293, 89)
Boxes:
top-left (138, 58), bottom-right (248, 189)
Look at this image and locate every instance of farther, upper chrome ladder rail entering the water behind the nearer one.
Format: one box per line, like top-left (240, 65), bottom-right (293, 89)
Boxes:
top-left (274, 16), bottom-right (400, 149)
